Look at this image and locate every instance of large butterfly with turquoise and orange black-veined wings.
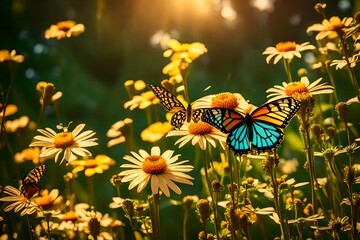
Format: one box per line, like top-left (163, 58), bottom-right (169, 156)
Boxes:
top-left (202, 97), bottom-right (300, 154)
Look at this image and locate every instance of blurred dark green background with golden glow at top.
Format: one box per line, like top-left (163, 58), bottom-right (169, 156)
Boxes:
top-left (0, 0), bottom-right (360, 239)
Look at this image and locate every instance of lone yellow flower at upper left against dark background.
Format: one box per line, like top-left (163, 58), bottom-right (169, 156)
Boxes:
top-left (45, 20), bottom-right (85, 40)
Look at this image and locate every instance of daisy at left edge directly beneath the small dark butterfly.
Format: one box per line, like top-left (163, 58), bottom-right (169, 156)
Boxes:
top-left (0, 186), bottom-right (38, 216)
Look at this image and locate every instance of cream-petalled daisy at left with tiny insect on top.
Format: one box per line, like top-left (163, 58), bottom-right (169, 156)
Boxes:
top-left (29, 124), bottom-right (98, 164)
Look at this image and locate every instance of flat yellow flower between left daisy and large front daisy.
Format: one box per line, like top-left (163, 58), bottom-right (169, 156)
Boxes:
top-left (70, 154), bottom-right (115, 177)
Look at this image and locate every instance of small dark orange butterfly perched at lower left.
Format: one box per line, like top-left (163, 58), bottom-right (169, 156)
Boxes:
top-left (20, 164), bottom-right (47, 197)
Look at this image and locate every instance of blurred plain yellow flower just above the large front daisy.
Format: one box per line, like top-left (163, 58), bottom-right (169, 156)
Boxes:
top-left (140, 122), bottom-right (174, 143)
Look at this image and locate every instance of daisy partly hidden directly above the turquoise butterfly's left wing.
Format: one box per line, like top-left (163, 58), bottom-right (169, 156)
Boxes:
top-left (192, 92), bottom-right (249, 112)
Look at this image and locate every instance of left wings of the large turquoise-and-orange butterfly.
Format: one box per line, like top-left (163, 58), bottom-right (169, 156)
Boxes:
top-left (202, 108), bottom-right (251, 154)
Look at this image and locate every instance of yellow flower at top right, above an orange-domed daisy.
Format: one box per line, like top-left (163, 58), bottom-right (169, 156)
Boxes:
top-left (306, 16), bottom-right (353, 40)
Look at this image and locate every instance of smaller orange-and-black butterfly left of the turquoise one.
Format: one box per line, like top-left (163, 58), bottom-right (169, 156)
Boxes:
top-left (148, 84), bottom-right (205, 129)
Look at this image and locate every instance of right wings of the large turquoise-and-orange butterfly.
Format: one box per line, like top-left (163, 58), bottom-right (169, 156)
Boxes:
top-left (250, 97), bottom-right (300, 152)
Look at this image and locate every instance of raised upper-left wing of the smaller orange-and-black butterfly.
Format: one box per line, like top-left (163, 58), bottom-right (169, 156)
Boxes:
top-left (148, 84), bottom-right (185, 112)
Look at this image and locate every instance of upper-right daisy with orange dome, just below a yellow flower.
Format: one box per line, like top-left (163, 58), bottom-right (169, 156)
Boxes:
top-left (262, 41), bottom-right (315, 64)
